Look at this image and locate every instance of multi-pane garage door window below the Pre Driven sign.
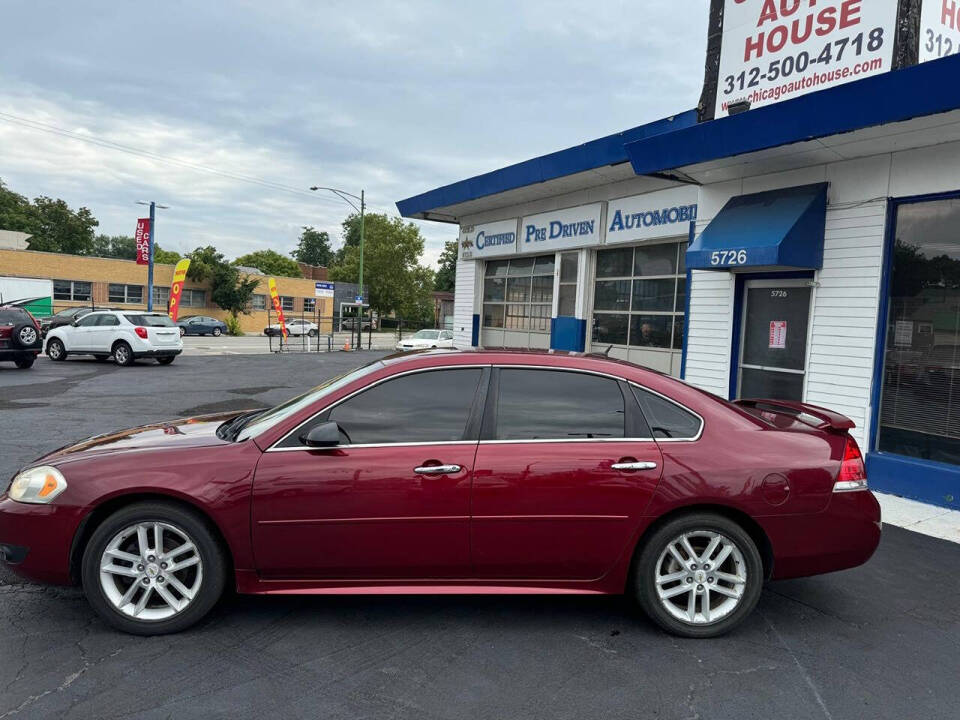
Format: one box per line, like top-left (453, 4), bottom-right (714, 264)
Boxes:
top-left (483, 255), bottom-right (556, 333)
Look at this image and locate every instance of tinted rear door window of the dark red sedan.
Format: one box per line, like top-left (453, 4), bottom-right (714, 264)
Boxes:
top-left (496, 369), bottom-right (624, 440)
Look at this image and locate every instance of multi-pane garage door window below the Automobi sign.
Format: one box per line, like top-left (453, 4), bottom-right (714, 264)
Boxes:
top-left (593, 242), bottom-right (687, 350)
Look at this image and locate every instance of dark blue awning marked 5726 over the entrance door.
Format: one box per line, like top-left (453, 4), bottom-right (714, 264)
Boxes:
top-left (687, 183), bottom-right (827, 270)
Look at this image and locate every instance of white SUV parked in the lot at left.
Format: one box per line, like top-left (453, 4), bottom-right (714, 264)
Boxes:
top-left (46, 310), bottom-right (183, 365)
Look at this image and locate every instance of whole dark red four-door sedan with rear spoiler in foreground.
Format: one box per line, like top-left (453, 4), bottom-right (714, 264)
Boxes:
top-left (0, 350), bottom-right (880, 637)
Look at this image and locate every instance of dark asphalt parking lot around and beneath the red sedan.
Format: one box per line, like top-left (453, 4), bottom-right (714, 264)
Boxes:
top-left (0, 353), bottom-right (960, 720)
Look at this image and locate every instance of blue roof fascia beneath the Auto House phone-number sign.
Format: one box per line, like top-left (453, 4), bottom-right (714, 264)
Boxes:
top-left (626, 54), bottom-right (960, 175)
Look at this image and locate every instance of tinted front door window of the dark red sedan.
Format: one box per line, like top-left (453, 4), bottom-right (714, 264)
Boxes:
top-left (329, 368), bottom-right (482, 445)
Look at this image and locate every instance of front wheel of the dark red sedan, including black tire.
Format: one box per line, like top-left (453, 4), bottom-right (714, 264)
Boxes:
top-left (82, 502), bottom-right (227, 635)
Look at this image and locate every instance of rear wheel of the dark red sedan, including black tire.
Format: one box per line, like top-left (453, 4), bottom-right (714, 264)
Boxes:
top-left (633, 513), bottom-right (763, 638)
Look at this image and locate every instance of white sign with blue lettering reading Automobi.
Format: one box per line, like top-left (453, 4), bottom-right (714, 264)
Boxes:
top-left (607, 186), bottom-right (697, 244)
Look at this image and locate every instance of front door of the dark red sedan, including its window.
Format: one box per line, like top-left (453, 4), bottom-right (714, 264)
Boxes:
top-left (253, 367), bottom-right (489, 580)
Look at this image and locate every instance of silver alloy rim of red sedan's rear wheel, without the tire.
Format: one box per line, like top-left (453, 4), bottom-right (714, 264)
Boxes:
top-left (654, 530), bottom-right (747, 626)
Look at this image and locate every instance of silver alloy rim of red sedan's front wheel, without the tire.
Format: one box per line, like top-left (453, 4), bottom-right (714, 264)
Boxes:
top-left (100, 522), bottom-right (203, 621)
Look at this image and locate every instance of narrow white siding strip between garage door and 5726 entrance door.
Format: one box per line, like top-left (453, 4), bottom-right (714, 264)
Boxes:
top-left (686, 270), bottom-right (734, 398)
